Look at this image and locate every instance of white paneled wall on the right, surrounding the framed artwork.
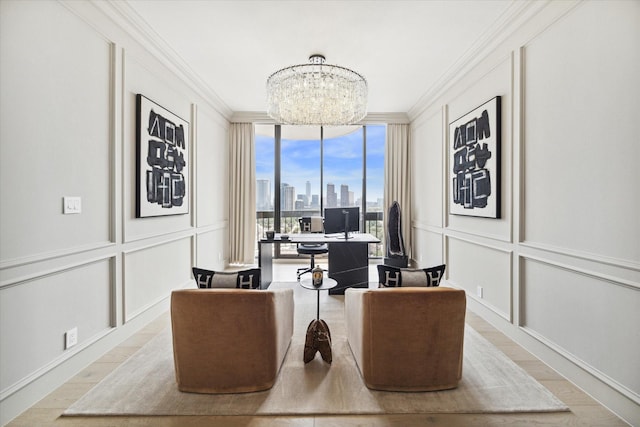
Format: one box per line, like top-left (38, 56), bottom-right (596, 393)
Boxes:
top-left (412, 1), bottom-right (640, 425)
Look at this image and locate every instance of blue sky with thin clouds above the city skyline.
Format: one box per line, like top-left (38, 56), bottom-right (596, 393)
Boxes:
top-left (256, 125), bottom-right (386, 202)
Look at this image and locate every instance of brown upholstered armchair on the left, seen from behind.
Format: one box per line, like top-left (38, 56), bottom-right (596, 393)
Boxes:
top-left (171, 289), bottom-right (294, 393)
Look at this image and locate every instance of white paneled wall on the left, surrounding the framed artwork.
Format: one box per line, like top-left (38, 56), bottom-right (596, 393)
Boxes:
top-left (0, 0), bottom-right (228, 424)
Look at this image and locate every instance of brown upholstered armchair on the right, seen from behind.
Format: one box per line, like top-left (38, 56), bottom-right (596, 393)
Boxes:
top-left (345, 287), bottom-right (466, 391)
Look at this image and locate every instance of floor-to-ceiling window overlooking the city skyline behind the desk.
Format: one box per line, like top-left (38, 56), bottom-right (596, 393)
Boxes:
top-left (255, 125), bottom-right (386, 257)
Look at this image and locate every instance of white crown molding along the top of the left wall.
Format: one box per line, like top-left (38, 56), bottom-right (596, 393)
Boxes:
top-left (91, 0), bottom-right (233, 120)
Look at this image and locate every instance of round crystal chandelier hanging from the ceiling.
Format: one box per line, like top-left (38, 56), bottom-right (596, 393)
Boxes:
top-left (267, 55), bottom-right (368, 126)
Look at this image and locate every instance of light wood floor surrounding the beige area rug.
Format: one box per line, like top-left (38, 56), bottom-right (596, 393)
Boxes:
top-left (8, 263), bottom-right (627, 427)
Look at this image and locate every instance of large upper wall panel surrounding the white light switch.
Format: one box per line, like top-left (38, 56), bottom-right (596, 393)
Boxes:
top-left (0, 2), bottom-right (112, 265)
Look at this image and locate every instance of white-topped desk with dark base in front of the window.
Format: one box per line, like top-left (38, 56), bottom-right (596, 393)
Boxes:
top-left (258, 233), bottom-right (380, 295)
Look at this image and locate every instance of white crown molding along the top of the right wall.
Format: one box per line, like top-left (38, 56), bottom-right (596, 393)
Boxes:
top-left (408, 0), bottom-right (551, 121)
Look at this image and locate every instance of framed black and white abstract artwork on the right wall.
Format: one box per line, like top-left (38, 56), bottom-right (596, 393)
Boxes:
top-left (449, 96), bottom-right (501, 218)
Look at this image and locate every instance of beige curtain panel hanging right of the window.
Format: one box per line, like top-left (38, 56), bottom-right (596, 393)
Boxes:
top-left (384, 124), bottom-right (411, 259)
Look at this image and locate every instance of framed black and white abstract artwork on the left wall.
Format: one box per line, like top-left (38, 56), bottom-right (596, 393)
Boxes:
top-left (136, 94), bottom-right (190, 218)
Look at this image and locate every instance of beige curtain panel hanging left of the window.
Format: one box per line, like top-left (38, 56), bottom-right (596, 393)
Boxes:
top-left (229, 123), bottom-right (256, 264)
